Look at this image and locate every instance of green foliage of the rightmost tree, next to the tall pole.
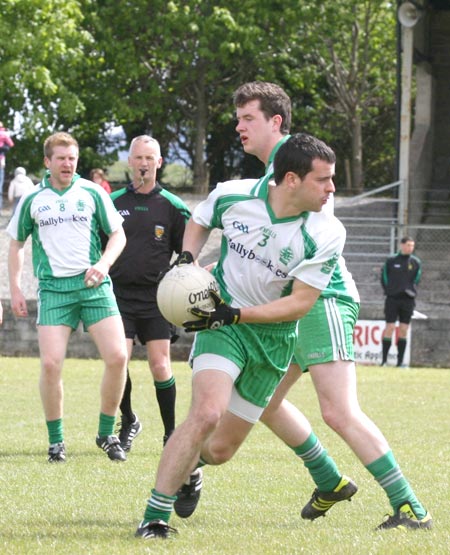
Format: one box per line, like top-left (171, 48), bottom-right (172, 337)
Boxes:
top-left (293, 0), bottom-right (396, 188)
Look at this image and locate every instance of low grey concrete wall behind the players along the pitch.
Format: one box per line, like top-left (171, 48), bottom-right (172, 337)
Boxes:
top-left (0, 301), bottom-right (450, 368)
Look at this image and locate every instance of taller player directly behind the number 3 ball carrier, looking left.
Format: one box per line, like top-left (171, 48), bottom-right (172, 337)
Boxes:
top-left (200, 82), bottom-right (432, 529)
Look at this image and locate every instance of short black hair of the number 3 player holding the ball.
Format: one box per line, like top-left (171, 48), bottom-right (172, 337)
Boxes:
top-left (273, 133), bottom-right (336, 185)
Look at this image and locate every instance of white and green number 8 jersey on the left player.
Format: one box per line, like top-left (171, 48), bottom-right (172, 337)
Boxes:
top-left (7, 176), bottom-right (123, 279)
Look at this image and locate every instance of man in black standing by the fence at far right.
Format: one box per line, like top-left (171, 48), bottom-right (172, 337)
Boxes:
top-left (381, 237), bottom-right (422, 367)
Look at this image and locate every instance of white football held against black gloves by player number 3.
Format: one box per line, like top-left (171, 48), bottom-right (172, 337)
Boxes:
top-left (156, 264), bottom-right (219, 327)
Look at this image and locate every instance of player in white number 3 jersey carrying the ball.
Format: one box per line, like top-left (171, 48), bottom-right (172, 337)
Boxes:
top-left (136, 134), bottom-right (345, 539)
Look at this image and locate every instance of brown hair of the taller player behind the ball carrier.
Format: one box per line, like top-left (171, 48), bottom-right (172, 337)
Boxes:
top-left (233, 81), bottom-right (292, 135)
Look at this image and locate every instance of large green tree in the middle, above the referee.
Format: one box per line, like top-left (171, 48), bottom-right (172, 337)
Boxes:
top-left (86, 0), bottom-right (304, 193)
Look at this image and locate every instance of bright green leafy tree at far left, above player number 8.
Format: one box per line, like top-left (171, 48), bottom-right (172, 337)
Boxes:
top-left (0, 0), bottom-right (98, 171)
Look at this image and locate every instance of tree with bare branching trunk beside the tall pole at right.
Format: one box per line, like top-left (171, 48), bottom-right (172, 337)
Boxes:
top-left (290, 0), bottom-right (396, 193)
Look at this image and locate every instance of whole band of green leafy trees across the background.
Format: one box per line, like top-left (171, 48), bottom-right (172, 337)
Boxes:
top-left (0, 0), bottom-right (396, 191)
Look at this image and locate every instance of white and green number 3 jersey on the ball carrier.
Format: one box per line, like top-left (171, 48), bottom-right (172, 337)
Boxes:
top-left (193, 176), bottom-right (359, 307)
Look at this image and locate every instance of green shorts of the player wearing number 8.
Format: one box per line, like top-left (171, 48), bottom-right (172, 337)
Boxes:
top-left (37, 273), bottom-right (120, 330)
